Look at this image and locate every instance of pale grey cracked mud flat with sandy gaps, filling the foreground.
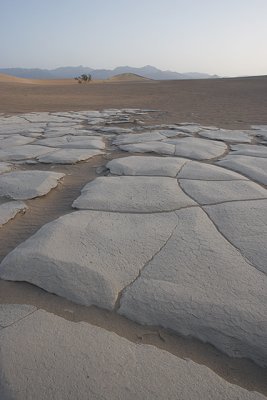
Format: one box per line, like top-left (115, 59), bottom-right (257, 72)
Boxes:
top-left (0, 109), bottom-right (267, 399)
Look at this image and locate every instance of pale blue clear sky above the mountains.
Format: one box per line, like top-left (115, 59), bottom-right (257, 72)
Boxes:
top-left (0, 0), bottom-right (267, 76)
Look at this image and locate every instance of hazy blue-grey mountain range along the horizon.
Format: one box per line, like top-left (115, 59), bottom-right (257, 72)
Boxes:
top-left (0, 65), bottom-right (219, 80)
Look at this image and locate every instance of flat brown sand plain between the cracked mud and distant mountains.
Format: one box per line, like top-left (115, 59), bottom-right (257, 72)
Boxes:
top-left (0, 75), bottom-right (267, 129)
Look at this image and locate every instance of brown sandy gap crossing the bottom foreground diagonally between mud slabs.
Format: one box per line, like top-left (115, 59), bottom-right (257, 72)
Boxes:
top-left (0, 279), bottom-right (267, 395)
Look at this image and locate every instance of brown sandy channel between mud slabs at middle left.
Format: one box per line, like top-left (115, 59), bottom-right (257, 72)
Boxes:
top-left (0, 156), bottom-right (107, 262)
